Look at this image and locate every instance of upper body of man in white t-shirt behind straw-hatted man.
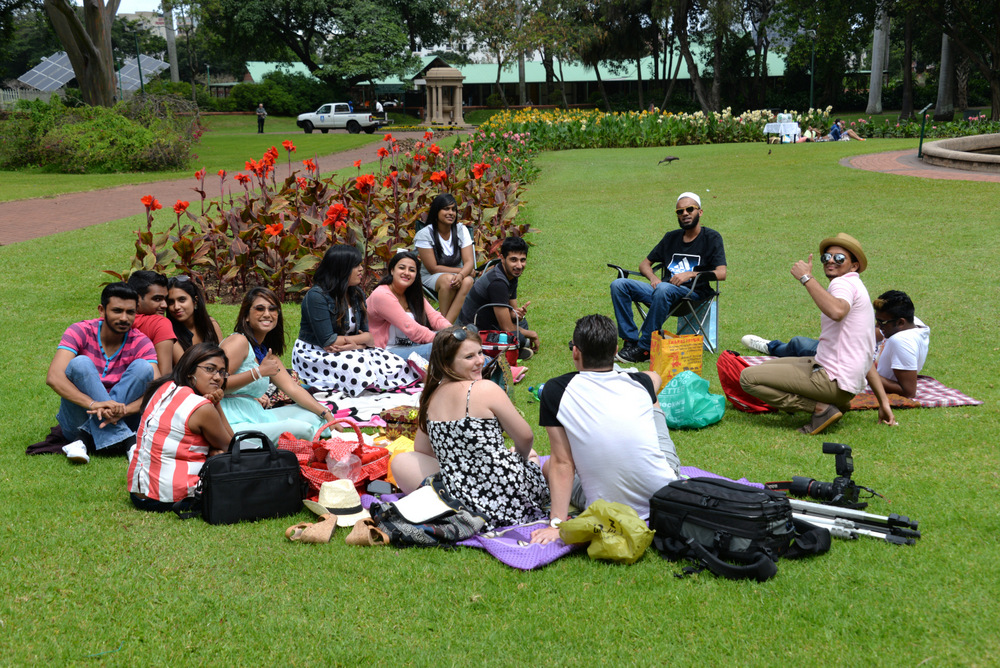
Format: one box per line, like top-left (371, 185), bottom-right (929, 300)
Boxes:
top-left (872, 290), bottom-right (931, 397)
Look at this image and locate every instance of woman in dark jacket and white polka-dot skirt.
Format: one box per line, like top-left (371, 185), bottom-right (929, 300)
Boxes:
top-left (292, 245), bottom-right (419, 397)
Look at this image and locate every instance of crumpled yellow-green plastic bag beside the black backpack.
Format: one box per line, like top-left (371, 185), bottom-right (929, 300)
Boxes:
top-left (559, 499), bottom-right (653, 564)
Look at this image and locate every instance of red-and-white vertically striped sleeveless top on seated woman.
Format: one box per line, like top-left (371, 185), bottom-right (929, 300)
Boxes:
top-left (128, 382), bottom-right (210, 503)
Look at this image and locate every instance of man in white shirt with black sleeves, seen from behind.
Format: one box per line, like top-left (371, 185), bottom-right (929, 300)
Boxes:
top-left (531, 315), bottom-right (680, 543)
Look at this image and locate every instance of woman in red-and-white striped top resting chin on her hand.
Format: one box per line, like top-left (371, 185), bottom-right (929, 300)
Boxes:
top-left (128, 343), bottom-right (233, 512)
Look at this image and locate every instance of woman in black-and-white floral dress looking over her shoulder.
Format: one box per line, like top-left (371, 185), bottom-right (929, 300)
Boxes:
top-left (390, 325), bottom-right (549, 526)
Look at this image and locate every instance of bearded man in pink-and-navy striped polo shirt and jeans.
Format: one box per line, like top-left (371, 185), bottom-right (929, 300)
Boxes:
top-left (45, 283), bottom-right (156, 464)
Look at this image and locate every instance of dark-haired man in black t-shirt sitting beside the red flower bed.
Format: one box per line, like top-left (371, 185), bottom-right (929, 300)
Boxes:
top-left (457, 237), bottom-right (539, 359)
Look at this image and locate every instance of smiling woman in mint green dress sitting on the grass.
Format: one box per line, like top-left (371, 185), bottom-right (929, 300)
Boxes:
top-left (220, 287), bottom-right (333, 443)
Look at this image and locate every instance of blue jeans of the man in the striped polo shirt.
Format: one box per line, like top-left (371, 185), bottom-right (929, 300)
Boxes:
top-left (56, 355), bottom-right (153, 451)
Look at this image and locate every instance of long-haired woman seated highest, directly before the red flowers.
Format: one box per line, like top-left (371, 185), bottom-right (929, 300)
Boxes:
top-left (413, 193), bottom-right (476, 322)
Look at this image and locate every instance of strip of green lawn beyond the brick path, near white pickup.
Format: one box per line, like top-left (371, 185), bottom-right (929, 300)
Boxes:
top-left (0, 116), bottom-right (382, 202)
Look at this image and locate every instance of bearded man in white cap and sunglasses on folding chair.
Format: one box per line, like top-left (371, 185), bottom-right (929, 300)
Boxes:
top-left (611, 192), bottom-right (726, 362)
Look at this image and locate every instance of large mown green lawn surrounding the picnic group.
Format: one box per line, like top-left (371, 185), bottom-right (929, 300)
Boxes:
top-left (0, 140), bottom-right (1000, 666)
